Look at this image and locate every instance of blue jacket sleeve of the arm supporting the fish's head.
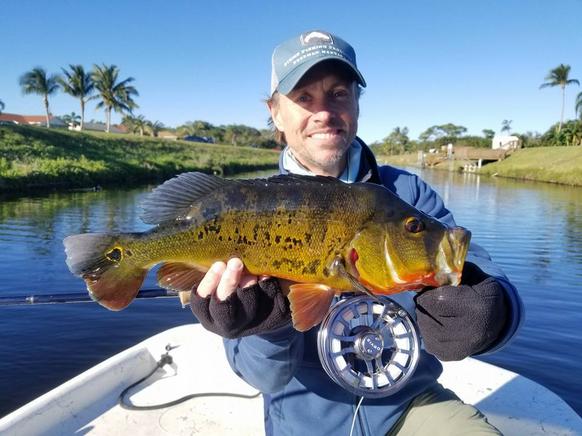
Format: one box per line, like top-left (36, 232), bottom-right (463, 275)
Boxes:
top-left (392, 169), bottom-right (524, 354)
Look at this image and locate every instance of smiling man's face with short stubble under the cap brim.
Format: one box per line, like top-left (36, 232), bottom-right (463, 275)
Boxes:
top-left (269, 62), bottom-right (359, 177)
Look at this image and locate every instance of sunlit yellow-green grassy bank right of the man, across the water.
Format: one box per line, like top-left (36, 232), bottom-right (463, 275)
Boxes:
top-left (378, 146), bottom-right (582, 186)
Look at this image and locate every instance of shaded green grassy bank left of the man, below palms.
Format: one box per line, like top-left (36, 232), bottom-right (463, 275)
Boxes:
top-left (0, 126), bottom-right (278, 192)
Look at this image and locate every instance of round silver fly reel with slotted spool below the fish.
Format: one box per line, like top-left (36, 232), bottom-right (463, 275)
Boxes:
top-left (317, 295), bottom-right (420, 398)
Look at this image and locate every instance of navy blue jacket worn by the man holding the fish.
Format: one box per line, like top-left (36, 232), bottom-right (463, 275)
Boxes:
top-left (224, 142), bottom-right (523, 436)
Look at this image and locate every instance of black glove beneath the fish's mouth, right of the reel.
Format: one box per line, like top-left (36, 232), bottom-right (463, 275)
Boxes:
top-left (415, 262), bottom-right (508, 361)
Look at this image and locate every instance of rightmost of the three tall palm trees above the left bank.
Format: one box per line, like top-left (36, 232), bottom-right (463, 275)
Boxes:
top-left (91, 64), bottom-right (139, 132)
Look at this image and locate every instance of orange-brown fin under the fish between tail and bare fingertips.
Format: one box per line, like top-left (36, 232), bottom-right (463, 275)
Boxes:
top-left (158, 262), bottom-right (207, 296)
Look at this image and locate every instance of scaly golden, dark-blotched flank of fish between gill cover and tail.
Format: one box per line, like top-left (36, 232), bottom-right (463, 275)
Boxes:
top-left (128, 177), bottom-right (371, 284)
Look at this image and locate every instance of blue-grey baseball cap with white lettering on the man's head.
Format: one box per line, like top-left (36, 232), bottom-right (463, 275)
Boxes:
top-left (271, 30), bottom-right (366, 95)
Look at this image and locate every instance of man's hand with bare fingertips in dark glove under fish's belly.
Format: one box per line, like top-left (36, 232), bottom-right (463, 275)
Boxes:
top-left (190, 258), bottom-right (291, 338)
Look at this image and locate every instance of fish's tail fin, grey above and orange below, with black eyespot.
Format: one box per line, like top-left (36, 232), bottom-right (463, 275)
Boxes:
top-left (63, 233), bottom-right (148, 310)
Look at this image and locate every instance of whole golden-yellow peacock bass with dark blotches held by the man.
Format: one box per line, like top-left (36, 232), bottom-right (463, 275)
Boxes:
top-left (64, 172), bottom-right (470, 331)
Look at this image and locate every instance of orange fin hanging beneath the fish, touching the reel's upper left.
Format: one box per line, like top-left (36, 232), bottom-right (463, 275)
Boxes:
top-left (287, 283), bottom-right (335, 332)
